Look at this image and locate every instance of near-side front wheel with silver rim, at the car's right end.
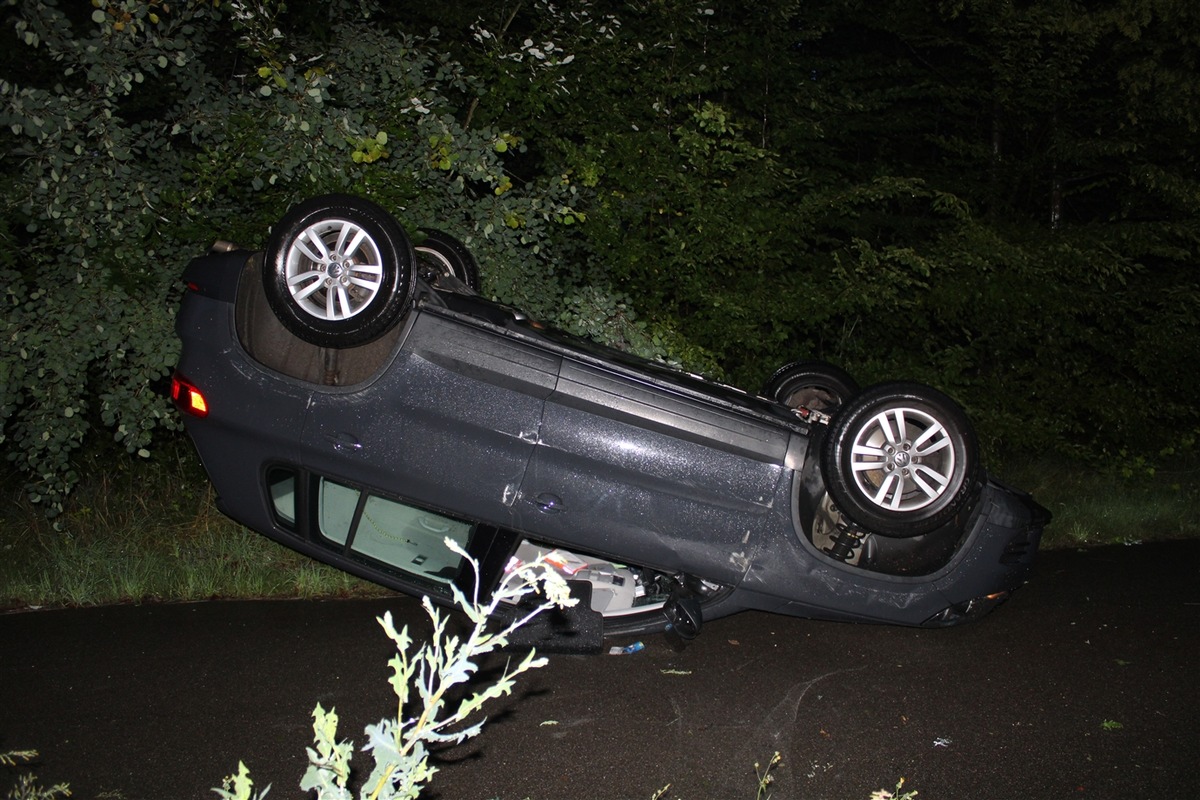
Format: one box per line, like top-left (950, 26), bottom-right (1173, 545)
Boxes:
top-left (821, 383), bottom-right (979, 537)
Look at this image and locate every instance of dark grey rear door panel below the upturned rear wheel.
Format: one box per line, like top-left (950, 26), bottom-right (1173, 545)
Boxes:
top-left (304, 309), bottom-right (559, 525)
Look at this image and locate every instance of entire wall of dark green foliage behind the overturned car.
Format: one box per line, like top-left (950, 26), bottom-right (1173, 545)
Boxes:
top-left (0, 0), bottom-right (1200, 513)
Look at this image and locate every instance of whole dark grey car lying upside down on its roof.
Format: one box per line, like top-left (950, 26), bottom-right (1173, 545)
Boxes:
top-left (173, 196), bottom-right (1049, 637)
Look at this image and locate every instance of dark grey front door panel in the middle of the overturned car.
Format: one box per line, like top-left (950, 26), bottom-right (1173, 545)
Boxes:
top-left (517, 356), bottom-right (790, 583)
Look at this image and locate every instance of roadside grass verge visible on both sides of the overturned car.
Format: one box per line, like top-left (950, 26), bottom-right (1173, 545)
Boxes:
top-left (0, 444), bottom-right (1200, 608)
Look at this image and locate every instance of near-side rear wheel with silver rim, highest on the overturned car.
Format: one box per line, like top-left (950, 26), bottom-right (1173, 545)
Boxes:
top-left (263, 194), bottom-right (416, 348)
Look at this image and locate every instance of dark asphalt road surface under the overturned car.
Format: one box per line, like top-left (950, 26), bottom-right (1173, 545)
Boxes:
top-left (0, 542), bottom-right (1200, 800)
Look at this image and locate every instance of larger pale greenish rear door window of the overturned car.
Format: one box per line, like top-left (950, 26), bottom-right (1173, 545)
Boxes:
top-left (317, 477), bottom-right (473, 584)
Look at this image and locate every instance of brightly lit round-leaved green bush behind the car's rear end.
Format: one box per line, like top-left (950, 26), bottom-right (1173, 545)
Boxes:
top-left (0, 0), bottom-right (609, 513)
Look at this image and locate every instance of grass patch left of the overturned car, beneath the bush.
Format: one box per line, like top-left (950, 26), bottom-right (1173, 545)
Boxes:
top-left (0, 450), bottom-right (389, 607)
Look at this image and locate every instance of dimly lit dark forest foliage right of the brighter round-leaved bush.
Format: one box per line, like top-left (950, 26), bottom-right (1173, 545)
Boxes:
top-left (444, 0), bottom-right (1200, 459)
